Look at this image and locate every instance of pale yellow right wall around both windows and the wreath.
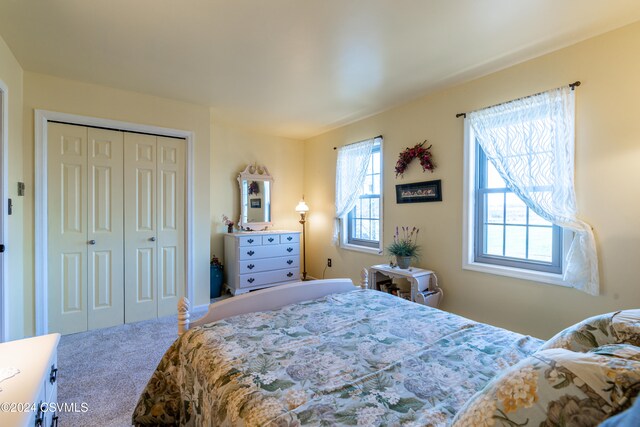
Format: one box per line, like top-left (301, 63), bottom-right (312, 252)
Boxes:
top-left (304, 24), bottom-right (640, 338)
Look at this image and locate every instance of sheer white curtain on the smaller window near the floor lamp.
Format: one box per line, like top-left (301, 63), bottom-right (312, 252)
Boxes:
top-left (333, 138), bottom-right (374, 243)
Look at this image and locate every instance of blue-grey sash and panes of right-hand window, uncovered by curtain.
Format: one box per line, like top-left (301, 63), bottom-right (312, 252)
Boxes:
top-left (474, 141), bottom-right (562, 274)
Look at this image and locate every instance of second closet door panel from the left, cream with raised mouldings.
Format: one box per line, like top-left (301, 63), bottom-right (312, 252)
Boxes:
top-left (88, 128), bottom-right (124, 329)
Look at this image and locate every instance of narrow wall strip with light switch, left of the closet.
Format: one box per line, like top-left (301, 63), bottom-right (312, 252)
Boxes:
top-left (0, 38), bottom-right (26, 339)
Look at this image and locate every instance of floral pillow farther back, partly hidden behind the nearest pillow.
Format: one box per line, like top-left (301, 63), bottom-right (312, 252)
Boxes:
top-left (539, 310), bottom-right (640, 352)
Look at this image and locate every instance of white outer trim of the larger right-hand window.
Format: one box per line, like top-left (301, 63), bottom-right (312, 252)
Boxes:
top-left (462, 119), bottom-right (573, 286)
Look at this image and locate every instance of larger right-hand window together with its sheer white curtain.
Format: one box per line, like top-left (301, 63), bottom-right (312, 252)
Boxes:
top-left (463, 86), bottom-right (599, 295)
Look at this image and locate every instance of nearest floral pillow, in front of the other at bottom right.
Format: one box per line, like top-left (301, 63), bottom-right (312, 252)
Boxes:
top-left (452, 349), bottom-right (640, 427)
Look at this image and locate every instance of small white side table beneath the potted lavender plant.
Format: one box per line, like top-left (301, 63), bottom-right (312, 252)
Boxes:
top-left (363, 264), bottom-right (443, 308)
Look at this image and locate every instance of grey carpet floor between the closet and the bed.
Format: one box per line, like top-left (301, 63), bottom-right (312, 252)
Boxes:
top-left (58, 309), bottom-right (205, 427)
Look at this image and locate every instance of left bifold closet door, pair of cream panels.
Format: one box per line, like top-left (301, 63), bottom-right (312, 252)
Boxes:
top-left (47, 123), bottom-right (124, 333)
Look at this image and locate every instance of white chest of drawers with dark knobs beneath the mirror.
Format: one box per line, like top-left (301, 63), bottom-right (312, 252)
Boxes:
top-left (224, 231), bottom-right (300, 295)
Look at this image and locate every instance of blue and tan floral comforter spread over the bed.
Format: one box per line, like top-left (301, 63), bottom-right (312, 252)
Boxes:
top-left (133, 290), bottom-right (542, 426)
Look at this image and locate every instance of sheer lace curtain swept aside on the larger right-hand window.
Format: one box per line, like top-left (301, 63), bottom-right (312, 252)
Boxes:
top-left (467, 87), bottom-right (599, 295)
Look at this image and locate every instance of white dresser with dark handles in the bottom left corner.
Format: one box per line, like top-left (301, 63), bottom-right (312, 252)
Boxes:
top-left (0, 334), bottom-right (60, 427)
